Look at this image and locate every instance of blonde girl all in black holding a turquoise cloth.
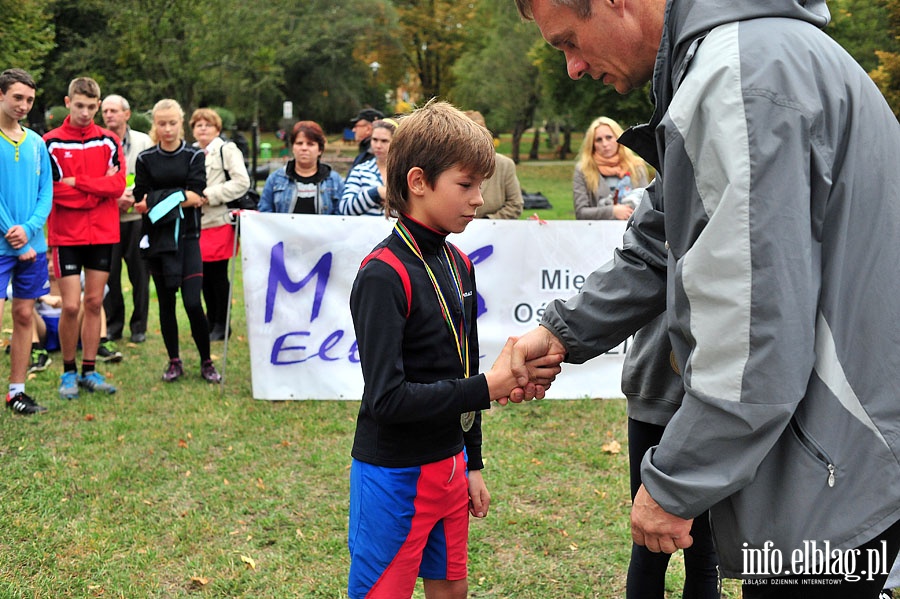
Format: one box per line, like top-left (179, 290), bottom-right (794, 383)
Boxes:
top-left (134, 98), bottom-right (222, 383)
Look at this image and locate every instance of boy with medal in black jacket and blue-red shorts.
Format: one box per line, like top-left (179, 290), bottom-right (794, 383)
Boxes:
top-left (348, 101), bottom-right (562, 599)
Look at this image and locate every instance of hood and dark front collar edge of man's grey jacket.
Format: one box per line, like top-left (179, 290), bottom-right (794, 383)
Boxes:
top-left (619, 0), bottom-right (831, 170)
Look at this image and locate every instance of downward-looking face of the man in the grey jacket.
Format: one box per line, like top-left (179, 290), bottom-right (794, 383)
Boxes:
top-left (532, 0), bottom-right (662, 94)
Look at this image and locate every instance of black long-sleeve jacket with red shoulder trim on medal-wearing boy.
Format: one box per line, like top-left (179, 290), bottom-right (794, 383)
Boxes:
top-left (350, 216), bottom-right (490, 470)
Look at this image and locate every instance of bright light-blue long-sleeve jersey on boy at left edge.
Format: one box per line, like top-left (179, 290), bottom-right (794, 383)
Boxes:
top-left (0, 129), bottom-right (53, 256)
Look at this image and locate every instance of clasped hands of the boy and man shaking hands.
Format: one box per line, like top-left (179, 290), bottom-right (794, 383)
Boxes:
top-left (485, 327), bottom-right (566, 406)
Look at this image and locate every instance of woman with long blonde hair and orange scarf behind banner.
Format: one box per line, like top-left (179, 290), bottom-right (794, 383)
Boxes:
top-left (572, 116), bottom-right (648, 220)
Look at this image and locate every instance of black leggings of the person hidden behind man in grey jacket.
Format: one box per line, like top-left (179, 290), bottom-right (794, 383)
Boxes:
top-left (625, 418), bottom-right (719, 599)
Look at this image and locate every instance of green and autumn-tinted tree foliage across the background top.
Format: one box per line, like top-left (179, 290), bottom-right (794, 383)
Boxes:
top-left (12, 0), bottom-right (900, 131)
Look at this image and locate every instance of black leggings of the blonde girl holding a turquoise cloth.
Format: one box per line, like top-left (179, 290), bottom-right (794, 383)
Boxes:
top-left (150, 239), bottom-right (209, 362)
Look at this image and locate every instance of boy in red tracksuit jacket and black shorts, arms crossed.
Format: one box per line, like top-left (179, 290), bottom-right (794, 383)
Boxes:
top-left (44, 77), bottom-right (126, 399)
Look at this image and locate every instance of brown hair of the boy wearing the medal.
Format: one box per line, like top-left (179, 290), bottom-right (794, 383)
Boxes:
top-left (384, 98), bottom-right (495, 216)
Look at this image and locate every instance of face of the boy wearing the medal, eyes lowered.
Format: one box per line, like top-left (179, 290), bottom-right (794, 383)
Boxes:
top-left (409, 166), bottom-right (484, 233)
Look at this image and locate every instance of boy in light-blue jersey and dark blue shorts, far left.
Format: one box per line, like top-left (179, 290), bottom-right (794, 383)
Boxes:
top-left (0, 69), bottom-right (53, 414)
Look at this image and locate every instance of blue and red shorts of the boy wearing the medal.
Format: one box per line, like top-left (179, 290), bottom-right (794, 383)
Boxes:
top-left (347, 452), bottom-right (469, 599)
